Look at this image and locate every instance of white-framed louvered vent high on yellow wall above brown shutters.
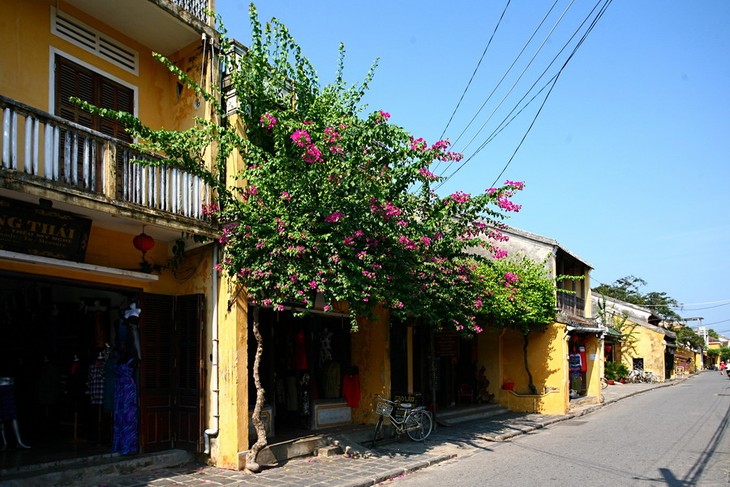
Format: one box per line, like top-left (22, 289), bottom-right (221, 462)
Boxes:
top-left (51, 8), bottom-right (139, 74)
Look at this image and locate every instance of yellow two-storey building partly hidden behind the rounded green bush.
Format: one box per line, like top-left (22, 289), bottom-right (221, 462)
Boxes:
top-left (466, 228), bottom-right (603, 414)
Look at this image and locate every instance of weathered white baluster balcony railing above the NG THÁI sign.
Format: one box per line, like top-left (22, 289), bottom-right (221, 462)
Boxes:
top-left (0, 96), bottom-right (212, 219)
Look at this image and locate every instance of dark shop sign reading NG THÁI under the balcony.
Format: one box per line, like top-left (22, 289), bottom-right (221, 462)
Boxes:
top-left (0, 198), bottom-right (91, 262)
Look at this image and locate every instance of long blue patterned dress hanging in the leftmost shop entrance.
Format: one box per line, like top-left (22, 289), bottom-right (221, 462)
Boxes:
top-left (112, 359), bottom-right (139, 455)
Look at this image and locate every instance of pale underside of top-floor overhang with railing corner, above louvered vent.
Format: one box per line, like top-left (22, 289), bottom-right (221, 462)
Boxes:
top-left (62, 0), bottom-right (215, 56)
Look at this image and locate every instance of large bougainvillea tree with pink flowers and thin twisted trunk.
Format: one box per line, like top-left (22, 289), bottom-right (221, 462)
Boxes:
top-left (77, 5), bottom-right (523, 469)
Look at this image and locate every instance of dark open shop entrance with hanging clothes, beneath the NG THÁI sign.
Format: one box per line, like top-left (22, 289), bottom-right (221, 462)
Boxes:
top-left (0, 273), bottom-right (204, 466)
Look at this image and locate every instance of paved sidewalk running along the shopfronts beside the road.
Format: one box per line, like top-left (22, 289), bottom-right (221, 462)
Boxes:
top-left (5, 378), bottom-right (685, 487)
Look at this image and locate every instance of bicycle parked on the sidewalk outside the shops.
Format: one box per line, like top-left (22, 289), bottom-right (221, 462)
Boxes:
top-left (373, 394), bottom-right (433, 447)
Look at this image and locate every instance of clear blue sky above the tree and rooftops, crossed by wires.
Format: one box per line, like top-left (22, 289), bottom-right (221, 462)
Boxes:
top-left (216, 0), bottom-right (730, 335)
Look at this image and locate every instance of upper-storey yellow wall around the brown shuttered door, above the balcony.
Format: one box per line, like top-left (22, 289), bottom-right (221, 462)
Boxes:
top-left (0, 0), bottom-right (206, 133)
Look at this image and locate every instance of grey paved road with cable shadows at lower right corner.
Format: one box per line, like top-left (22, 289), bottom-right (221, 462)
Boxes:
top-left (382, 372), bottom-right (730, 487)
